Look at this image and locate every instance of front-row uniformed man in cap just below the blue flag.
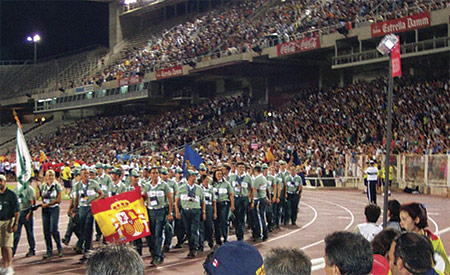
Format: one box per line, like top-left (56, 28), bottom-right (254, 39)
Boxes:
top-left (175, 170), bottom-right (206, 258)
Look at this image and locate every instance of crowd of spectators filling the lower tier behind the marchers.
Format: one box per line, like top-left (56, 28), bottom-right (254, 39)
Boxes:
top-left (2, 75), bottom-right (450, 182)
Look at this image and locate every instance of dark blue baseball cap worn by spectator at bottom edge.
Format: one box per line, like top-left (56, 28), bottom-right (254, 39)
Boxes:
top-left (203, 241), bottom-right (265, 275)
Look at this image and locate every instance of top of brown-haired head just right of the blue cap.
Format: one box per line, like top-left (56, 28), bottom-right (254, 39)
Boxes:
top-left (264, 248), bottom-right (311, 275)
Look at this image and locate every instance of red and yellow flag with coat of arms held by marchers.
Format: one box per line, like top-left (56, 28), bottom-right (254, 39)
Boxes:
top-left (91, 189), bottom-right (150, 243)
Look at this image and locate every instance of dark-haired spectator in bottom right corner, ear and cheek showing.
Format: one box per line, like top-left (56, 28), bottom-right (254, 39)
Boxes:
top-left (389, 232), bottom-right (438, 275)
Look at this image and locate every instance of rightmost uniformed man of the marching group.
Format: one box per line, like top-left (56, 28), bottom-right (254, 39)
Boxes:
top-left (285, 165), bottom-right (303, 225)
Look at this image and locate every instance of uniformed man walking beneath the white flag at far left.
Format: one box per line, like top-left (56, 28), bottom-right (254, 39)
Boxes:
top-left (12, 181), bottom-right (36, 257)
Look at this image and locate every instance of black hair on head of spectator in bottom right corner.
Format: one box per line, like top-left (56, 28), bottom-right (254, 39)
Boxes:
top-left (391, 232), bottom-right (435, 274)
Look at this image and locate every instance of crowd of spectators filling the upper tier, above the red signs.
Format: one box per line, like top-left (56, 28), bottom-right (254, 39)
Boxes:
top-left (72, 0), bottom-right (450, 86)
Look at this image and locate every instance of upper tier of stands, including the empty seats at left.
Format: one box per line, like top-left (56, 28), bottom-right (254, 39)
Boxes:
top-left (0, 0), bottom-right (450, 97)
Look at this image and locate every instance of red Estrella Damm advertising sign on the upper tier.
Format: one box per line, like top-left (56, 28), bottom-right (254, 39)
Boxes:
top-left (370, 12), bottom-right (431, 37)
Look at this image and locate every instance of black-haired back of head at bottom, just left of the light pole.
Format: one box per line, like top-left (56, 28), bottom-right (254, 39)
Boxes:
top-left (325, 231), bottom-right (373, 275)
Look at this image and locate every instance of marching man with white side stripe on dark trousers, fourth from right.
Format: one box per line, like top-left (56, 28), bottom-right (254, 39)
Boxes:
top-left (250, 165), bottom-right (271, 242)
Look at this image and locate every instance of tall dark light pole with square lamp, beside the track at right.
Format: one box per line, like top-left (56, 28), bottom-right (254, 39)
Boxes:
top-left (377, 34), bottom-right (400, 227)
